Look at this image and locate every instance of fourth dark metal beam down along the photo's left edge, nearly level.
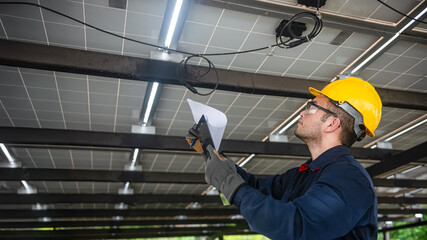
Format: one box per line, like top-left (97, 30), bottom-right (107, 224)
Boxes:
top-left (0, 193), bottom-right (427, 205)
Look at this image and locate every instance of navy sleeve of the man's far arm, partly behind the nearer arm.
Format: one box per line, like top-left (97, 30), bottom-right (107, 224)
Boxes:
top-left (236, 165), bottom-right (288, 199)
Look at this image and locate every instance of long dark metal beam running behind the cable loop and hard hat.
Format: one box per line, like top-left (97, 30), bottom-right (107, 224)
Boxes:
top-left (0, 40), bottom-right (427, 110)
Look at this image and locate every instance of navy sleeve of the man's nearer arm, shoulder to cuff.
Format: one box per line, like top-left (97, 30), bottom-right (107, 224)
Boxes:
top-left (234, 162), bottom-right (375, 239)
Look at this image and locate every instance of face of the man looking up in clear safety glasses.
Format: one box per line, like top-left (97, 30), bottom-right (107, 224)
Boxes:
top-left (294, 95), bottom-right (329, 143)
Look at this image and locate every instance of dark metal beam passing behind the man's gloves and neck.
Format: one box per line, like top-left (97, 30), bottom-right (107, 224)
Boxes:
top-left (0, 127), bottom-right (400, 159)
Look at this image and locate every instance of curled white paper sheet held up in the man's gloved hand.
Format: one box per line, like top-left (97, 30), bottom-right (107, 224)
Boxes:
top-left (187, 99), bottom-right (227, 151)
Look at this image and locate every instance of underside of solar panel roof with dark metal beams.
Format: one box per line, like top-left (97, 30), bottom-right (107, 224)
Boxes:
top-left (0, 0), bottom-right (427, 239)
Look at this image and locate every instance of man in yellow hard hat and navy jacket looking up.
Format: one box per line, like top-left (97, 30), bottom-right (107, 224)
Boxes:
top-left (187, 77), bottom-right (382, 240)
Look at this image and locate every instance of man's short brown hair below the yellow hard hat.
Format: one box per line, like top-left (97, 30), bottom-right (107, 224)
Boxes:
top-left (322, 101), bottom-right (357, 147)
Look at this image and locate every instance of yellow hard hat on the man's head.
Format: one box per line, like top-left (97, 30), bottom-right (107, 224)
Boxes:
top-left (309, 77), bottom-right (382, 137)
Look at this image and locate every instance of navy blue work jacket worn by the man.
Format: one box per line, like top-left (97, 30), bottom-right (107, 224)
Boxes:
top-left (233, 145), bottom-right (377, 240)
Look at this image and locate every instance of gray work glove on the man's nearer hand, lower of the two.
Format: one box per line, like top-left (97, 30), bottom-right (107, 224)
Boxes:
top-left (205, 145), bottom-right (245, 203)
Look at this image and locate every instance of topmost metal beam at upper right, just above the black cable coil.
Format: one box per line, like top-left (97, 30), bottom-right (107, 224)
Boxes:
top-left (192, 0), bottom-right (427, 44)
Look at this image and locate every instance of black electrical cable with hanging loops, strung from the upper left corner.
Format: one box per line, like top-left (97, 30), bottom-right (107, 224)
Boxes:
top-left (0, 2), bottom-right (322, 96)
